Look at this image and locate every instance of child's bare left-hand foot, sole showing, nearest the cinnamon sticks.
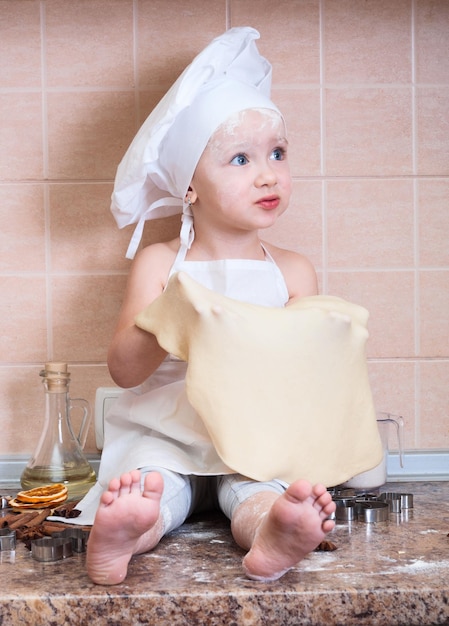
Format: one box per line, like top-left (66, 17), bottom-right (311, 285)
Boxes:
top-left (87, 470), bottom-right (164, 585)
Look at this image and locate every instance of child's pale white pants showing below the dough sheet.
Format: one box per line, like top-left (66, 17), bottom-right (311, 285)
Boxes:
top-left (141, 466), bottom-right (287, 535)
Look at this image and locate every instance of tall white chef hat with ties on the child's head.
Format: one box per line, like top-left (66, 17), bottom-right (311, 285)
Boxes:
top-left (111, 27), bottom-right (279, 259)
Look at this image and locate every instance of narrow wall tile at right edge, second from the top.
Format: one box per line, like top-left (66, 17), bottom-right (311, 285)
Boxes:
top-left (416, 86), bottom-right (449, 176)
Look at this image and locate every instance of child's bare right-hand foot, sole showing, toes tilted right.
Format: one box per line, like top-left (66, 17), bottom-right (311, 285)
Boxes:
top-left (243, 480), bottom-right (335, 581)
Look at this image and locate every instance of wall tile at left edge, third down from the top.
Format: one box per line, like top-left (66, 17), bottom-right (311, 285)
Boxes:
top-left (0, 183), bottom-right (46, 272)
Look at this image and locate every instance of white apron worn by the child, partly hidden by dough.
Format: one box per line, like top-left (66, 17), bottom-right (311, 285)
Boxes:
top-left (70, 247), bottom-right (289, 524)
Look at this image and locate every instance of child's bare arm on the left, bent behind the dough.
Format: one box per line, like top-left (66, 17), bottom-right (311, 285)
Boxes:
top-left (108, 242), bottom-right (175, 387)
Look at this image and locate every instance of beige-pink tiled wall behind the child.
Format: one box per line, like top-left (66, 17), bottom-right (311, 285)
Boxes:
top-left (0, 0), bottom-right (449, 454)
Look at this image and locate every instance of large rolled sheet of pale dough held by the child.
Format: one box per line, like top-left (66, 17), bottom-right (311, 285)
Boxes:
top-left (135, 273), bottom-right (383, 487)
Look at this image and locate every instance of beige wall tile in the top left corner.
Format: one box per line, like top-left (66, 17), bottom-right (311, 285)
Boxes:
top-left (0, 0), bottom-right (42, 89)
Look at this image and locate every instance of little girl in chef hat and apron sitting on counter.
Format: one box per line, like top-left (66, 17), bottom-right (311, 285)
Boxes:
top-left (78, 28), bottom-right (334, 584)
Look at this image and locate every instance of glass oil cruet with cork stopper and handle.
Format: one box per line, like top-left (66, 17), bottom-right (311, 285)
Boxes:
top-left (20, 362), bottom-right (96, 501)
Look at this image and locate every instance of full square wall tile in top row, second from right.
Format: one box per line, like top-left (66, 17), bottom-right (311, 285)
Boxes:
top-left (324, 0), bottom-right (412, 84)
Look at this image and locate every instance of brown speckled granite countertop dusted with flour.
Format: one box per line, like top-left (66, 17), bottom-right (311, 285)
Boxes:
top-left (0, 482), bottom-right (449, 626)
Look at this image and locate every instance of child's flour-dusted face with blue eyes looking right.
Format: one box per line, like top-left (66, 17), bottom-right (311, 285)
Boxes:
top-left (191, 109), bottom-right (292, 232)
